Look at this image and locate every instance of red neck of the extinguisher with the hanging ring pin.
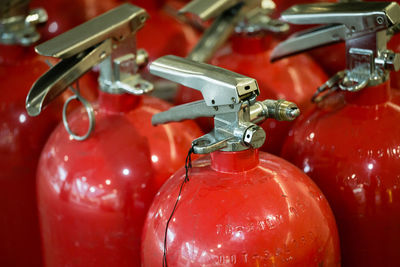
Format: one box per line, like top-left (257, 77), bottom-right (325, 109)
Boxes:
top-left (99, 90), bottom-right (142, 113)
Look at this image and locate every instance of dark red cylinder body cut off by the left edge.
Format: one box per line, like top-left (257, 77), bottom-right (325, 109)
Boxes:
top-left (0, 46), bottom-right (58, 266)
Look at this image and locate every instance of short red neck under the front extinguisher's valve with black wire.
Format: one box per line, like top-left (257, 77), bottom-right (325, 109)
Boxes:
top-left (211, 148), bottom-right (259, 173)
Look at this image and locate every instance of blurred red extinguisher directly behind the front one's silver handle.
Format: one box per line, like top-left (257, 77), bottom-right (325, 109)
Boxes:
top-left (176, 1), bottom-right (327, 154)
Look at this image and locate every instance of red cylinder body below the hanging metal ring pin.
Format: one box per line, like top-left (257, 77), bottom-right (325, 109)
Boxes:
top-left (38, 93), bottom-right (201, 267)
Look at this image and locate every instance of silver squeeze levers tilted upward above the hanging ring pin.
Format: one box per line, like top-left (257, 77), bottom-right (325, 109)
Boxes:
top-left (26, 4), bottom-right (150, 116)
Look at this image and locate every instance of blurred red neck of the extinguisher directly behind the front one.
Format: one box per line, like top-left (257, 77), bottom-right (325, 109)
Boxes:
top-left (231, 34), bottom-right (273, 54)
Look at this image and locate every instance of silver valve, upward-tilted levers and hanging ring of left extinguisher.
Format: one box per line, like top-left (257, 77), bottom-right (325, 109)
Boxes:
top-left (26, 4), bottom-right (153, 140)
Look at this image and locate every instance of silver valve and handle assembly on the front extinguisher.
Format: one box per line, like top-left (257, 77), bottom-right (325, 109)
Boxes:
top-left (150, 56), bottom-right (299, 154)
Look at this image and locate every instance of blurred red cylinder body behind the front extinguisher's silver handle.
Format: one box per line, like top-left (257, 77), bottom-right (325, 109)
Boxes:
top-left (175, 36), bottom-right (327, 154)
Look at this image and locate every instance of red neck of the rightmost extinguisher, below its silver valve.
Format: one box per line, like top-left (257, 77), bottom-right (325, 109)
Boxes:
top-left (345, 80), bottom-right (391, 106)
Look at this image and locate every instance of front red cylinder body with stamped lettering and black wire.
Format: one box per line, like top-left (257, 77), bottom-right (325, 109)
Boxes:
top-left (142, 150), bottom-right (340, 267)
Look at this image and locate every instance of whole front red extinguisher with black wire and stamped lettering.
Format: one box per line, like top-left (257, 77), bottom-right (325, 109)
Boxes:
top-left (142, 56), bottom-right (340, 267)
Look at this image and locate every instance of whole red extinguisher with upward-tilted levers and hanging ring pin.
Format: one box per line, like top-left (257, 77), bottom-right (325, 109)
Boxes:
top-left (26, 4), bottom-right (201, 267)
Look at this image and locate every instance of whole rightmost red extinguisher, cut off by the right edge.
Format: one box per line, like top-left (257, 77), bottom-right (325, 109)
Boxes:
top-left (273, 2), bottom-right (400, 266)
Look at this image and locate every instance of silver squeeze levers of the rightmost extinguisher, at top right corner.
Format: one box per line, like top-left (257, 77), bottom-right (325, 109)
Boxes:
top-left (271, 2), bottom-right (400, 61)
